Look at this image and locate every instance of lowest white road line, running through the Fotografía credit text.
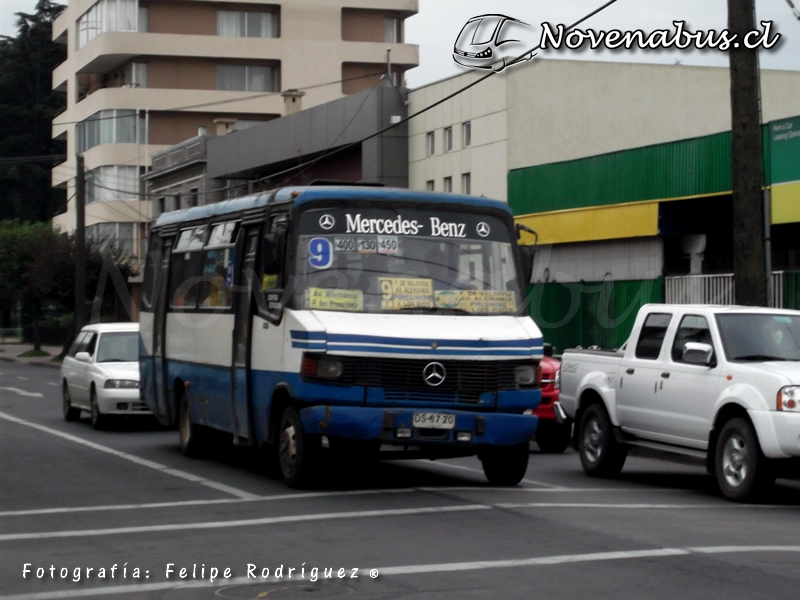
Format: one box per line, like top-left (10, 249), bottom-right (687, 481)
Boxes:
top-left (0, 546), bottom-right (800, 600)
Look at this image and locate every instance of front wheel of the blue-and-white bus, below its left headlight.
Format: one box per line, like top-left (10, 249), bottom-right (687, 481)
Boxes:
top-left (278, 406), bottom-right (320, 488)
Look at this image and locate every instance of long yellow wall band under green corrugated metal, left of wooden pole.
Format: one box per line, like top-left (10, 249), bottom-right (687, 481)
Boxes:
top-left (516, 202), bottom-right (658, 244)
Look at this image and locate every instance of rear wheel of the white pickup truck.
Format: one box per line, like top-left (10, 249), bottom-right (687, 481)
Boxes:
top-left (578, 404), bottom-right (628, 477)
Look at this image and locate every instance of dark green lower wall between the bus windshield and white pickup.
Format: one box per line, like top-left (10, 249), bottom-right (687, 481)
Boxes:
top-left (528, 277), bottom-right (664, 353)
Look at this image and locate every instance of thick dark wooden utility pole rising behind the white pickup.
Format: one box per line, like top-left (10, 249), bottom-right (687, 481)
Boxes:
top-left (728, 0), bottom-right (771, 306)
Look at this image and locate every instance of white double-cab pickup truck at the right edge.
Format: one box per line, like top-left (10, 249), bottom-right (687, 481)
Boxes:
top-left (555, 304), bottom-right (800, 501)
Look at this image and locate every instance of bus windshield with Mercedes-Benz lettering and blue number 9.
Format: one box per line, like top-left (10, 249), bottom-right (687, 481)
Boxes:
top-left (295, 208), bottom-right (523, 315)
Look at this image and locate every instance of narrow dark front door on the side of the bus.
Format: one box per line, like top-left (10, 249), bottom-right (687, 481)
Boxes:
top-left (232, 225), bottom-right (261, 444)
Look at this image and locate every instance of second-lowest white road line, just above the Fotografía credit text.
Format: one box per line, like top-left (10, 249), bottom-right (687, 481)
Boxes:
top-left (0, 504), bottom-right (492, 542)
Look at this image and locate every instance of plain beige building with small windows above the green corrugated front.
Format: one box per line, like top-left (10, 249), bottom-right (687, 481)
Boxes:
top-left (409, 59), bottom-right (800, 202)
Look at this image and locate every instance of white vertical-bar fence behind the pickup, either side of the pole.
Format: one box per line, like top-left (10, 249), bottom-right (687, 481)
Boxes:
top-left (665, 271), bottom-right (784, 308)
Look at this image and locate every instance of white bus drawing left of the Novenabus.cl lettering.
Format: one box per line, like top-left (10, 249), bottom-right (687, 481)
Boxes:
top-left (453, 15), bottom-right (536, 72)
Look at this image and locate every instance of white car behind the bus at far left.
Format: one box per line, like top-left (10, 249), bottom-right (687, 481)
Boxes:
top-left (61, 323), bottom-right (152, 429)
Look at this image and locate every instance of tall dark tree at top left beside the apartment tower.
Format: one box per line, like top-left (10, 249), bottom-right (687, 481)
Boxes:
top-left (0, 0), bottom-right (67, 221)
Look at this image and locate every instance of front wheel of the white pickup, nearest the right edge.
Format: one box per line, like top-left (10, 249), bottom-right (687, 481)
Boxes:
top-left (715, 417), bottom-right (775, 502)
